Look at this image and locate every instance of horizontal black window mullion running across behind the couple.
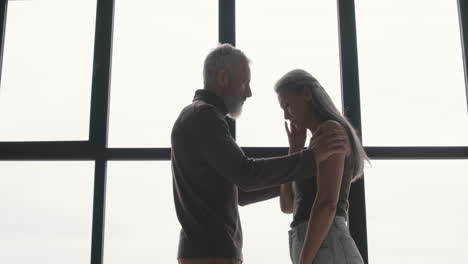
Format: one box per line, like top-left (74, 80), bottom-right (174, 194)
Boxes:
top-left (0, 144), bottom-right (468, 160)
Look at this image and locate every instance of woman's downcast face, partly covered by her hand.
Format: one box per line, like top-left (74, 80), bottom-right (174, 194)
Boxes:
top-left (278, 91), bottom-right (311, 128)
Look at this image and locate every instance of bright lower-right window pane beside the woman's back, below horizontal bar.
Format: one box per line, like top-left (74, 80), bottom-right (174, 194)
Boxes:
top-left (366, 160), bottom-right (468, 264)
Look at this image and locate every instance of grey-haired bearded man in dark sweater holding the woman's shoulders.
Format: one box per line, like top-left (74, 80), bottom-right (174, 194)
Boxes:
top-left (171, 44), bottom-right (346, 264)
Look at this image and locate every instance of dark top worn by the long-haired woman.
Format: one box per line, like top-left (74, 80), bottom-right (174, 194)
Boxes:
top-left (291, 156), bottom-right (353, 228)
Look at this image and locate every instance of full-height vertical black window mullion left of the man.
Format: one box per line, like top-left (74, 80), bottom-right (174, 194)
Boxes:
top-left (89, 0), bottom-right (114, 264)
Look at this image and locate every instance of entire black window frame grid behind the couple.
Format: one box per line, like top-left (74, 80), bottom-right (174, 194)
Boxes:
top-left (0, 0), bottom-right (468, 264)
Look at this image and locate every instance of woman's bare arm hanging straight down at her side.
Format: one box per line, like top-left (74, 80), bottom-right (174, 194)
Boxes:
top-left (300, 148), bottom-right (345, 264)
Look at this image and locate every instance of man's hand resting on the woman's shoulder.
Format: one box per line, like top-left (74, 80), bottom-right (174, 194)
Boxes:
top-left (309, 121), bottom-right (351, 163)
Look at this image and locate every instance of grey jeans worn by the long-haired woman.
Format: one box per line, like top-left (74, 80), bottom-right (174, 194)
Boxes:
top-left (289, 216), bottom-right (364, 264)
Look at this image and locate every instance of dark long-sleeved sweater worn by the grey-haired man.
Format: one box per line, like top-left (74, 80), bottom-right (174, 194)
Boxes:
top-left (171, 90), bottom-right (316, 261)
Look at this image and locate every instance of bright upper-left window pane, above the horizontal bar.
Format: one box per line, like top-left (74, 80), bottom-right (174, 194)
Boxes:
top-left (0, 0), bottom-right (96, 141)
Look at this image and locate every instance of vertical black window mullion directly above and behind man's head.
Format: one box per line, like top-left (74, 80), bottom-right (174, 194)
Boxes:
top-left (218, 0), bottom-right (236, 138)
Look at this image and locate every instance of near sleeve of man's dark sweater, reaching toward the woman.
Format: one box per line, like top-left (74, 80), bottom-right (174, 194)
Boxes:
top-left (192, 106), bottom-right (317, 191)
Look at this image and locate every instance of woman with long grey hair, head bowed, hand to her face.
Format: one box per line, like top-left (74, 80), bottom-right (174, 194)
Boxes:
top-left (275, 70), bottom-right (368, 264)
